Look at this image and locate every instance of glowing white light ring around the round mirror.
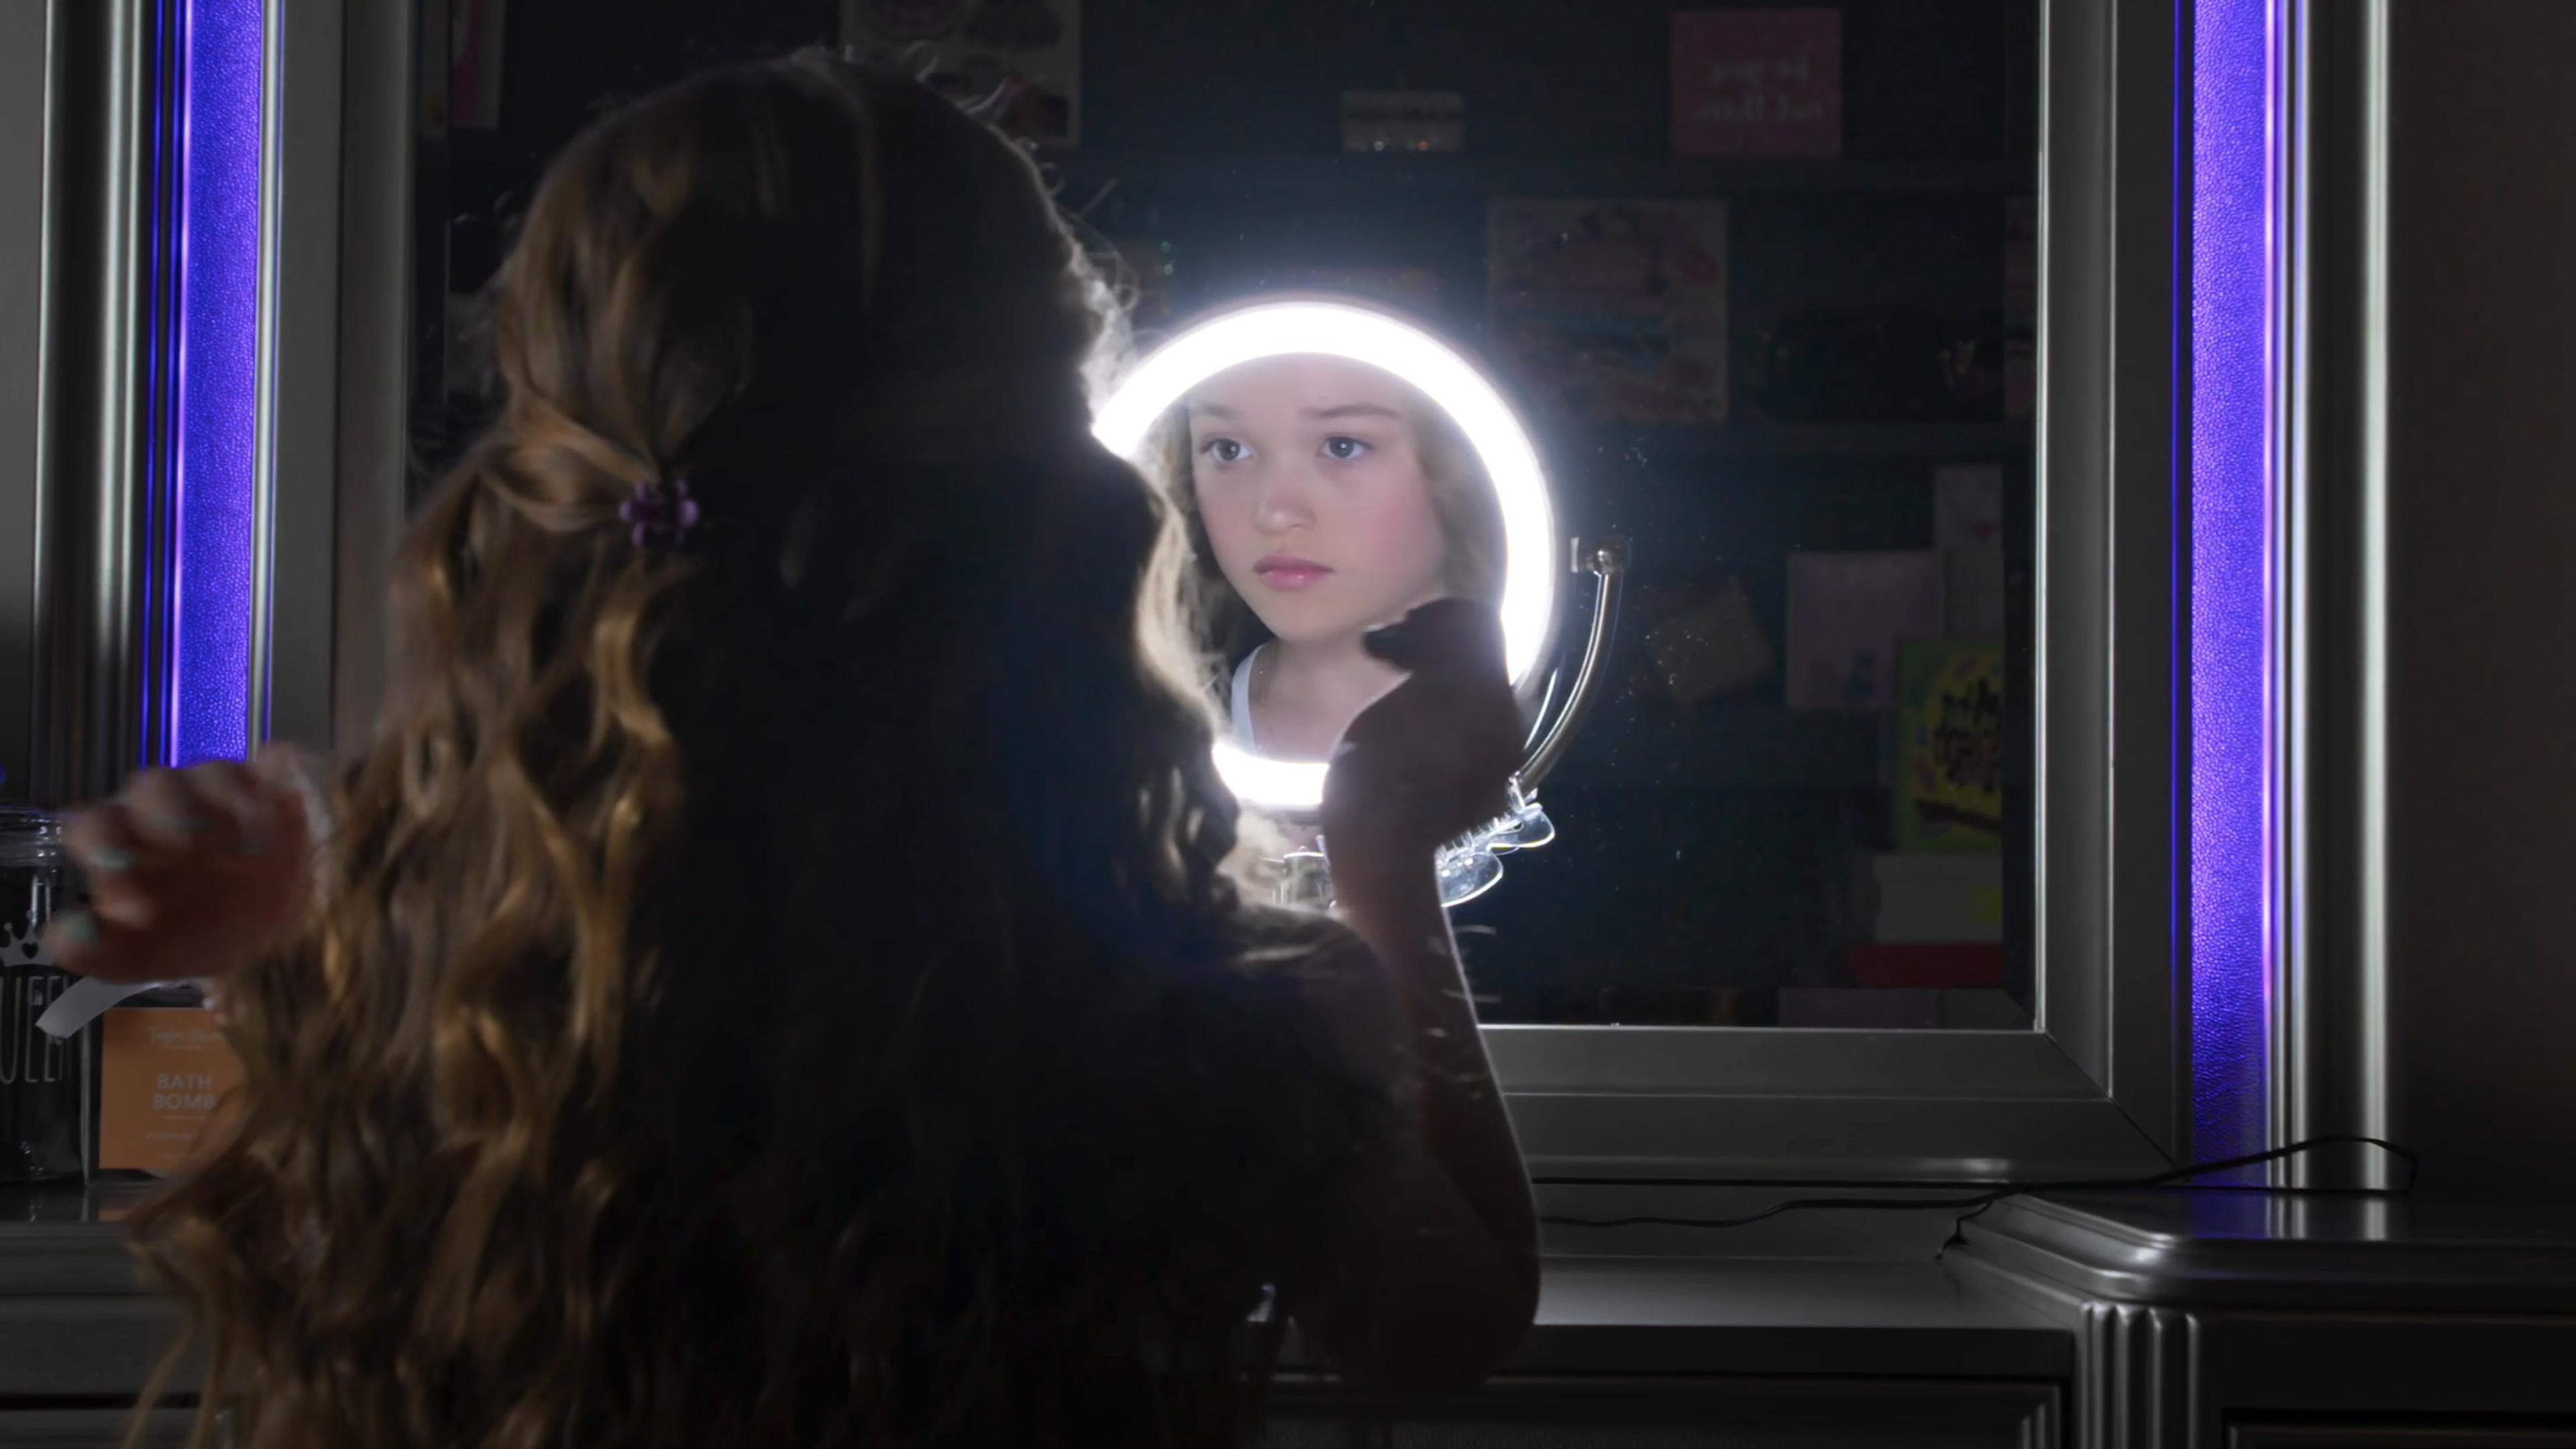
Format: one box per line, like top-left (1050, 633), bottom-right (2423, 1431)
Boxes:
top-left (1092, 302), bottom-right (1556, 810)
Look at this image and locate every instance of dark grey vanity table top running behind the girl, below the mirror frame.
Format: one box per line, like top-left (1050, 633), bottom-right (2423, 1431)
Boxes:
top-left (0, 1183), bottom-right (2576, 1392)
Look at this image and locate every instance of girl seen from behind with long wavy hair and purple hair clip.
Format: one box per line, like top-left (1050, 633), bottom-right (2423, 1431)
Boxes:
top-left (56, 59), bottom-right (1538, 1449)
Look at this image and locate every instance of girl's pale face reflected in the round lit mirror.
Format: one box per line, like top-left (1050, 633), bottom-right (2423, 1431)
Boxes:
top-left (1190, 356), bottom-right (1448, 642)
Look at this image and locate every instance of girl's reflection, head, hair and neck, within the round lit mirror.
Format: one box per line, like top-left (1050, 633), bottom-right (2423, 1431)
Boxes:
top-left (1167, 356), bottom-right (1502, 761)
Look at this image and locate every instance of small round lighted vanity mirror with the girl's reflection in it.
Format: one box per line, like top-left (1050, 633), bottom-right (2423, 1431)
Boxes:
top-left (1092, 297), bottom-right (1561, 814)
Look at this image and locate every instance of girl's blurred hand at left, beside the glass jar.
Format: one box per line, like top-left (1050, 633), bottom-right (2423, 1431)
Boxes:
top-left (46, 750), bottom-right (314, 982)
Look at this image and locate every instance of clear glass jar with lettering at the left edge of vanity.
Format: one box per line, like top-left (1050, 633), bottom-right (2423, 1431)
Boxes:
top-left (0, 804), bottom-right (83, 1183)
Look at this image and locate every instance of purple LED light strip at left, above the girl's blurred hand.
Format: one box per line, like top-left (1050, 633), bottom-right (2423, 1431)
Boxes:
top-left (157, 0), bottom-right (263, 763)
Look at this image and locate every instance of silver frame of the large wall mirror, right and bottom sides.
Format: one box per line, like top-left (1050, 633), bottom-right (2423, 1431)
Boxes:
top-left (1487, 0), bottom-right (2190, 1183)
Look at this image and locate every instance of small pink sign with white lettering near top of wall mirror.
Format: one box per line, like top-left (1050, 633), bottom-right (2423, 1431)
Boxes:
top-left (1672, 10), bottom-right (1842, 157)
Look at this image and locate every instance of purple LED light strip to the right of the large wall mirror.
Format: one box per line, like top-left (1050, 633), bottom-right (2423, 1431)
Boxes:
top-left (2190, 0), bottom-right (2277, 1158)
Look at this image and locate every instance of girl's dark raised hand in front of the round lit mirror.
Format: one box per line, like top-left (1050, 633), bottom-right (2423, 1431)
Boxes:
top-left (1324, 598), bottom-right (1522, 861)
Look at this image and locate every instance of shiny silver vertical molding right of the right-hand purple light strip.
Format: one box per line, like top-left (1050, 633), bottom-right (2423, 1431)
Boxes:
top-left (2272, 0), bottom-right (2396, 1189)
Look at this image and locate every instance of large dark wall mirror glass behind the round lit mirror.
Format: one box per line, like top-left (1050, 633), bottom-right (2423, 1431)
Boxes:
top-left (412, 0), bottom-right (2043, 1031)
